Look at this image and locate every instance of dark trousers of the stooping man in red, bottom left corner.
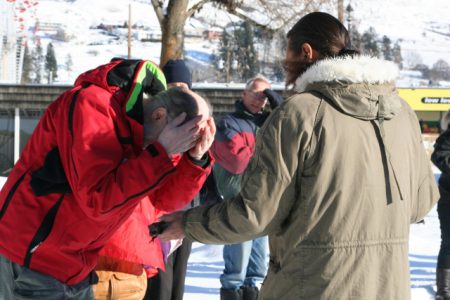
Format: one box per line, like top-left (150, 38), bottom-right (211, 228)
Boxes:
top-left (0, 255), bottom-right (93, 300)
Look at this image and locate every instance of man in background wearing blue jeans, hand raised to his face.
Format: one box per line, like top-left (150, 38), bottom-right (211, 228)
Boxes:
top-left (211, 75), bottom-right (282, 300)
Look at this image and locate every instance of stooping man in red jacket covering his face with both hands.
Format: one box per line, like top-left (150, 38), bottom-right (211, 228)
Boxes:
top-left (0, 60), bottom-right (215, 299)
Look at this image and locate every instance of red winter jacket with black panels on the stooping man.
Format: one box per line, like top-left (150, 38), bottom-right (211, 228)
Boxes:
top-left (0, 61), bottom-right (210, 285)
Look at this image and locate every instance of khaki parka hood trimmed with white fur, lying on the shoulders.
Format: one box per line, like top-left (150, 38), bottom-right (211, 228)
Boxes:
top-left (294, 55), bottom-right (401, 120)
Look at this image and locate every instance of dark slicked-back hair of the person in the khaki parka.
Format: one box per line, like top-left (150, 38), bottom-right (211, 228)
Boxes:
top-left (287, 12), bottom-right (359, 58)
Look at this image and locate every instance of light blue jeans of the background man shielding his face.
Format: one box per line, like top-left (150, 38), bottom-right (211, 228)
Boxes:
top-left (220, 236), bottom-right (268, 290)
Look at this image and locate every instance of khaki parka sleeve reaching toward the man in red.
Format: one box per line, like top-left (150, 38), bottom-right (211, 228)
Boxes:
top-left (183, 101), bottom-right (319, 243)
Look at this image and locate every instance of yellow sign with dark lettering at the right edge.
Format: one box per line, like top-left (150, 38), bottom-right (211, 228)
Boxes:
top-left (398, 88), bottom-right (450, 111)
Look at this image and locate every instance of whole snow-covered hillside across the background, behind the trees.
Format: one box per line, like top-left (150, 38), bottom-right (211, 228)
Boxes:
top-left (9, 0), bottom-right (450, 86)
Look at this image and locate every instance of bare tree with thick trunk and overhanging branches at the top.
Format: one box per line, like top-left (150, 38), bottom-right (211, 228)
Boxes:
top-left (151, 0), bottom-right (335, 65)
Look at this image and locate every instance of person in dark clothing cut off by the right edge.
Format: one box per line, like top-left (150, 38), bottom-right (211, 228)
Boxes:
top-left (431, 110), bottom-right (450, 300)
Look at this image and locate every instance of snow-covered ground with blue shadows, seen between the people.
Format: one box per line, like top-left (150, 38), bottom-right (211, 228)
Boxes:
top-left (0, 172), bottom-right (440, 300)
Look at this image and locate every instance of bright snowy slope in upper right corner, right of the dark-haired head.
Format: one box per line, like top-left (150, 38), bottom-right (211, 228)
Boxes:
top-left (354, 0), bottom-right (450, 67)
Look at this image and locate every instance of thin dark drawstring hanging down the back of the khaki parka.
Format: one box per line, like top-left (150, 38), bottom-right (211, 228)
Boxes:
top-left (371, 95), bottom-right (403, 204)
